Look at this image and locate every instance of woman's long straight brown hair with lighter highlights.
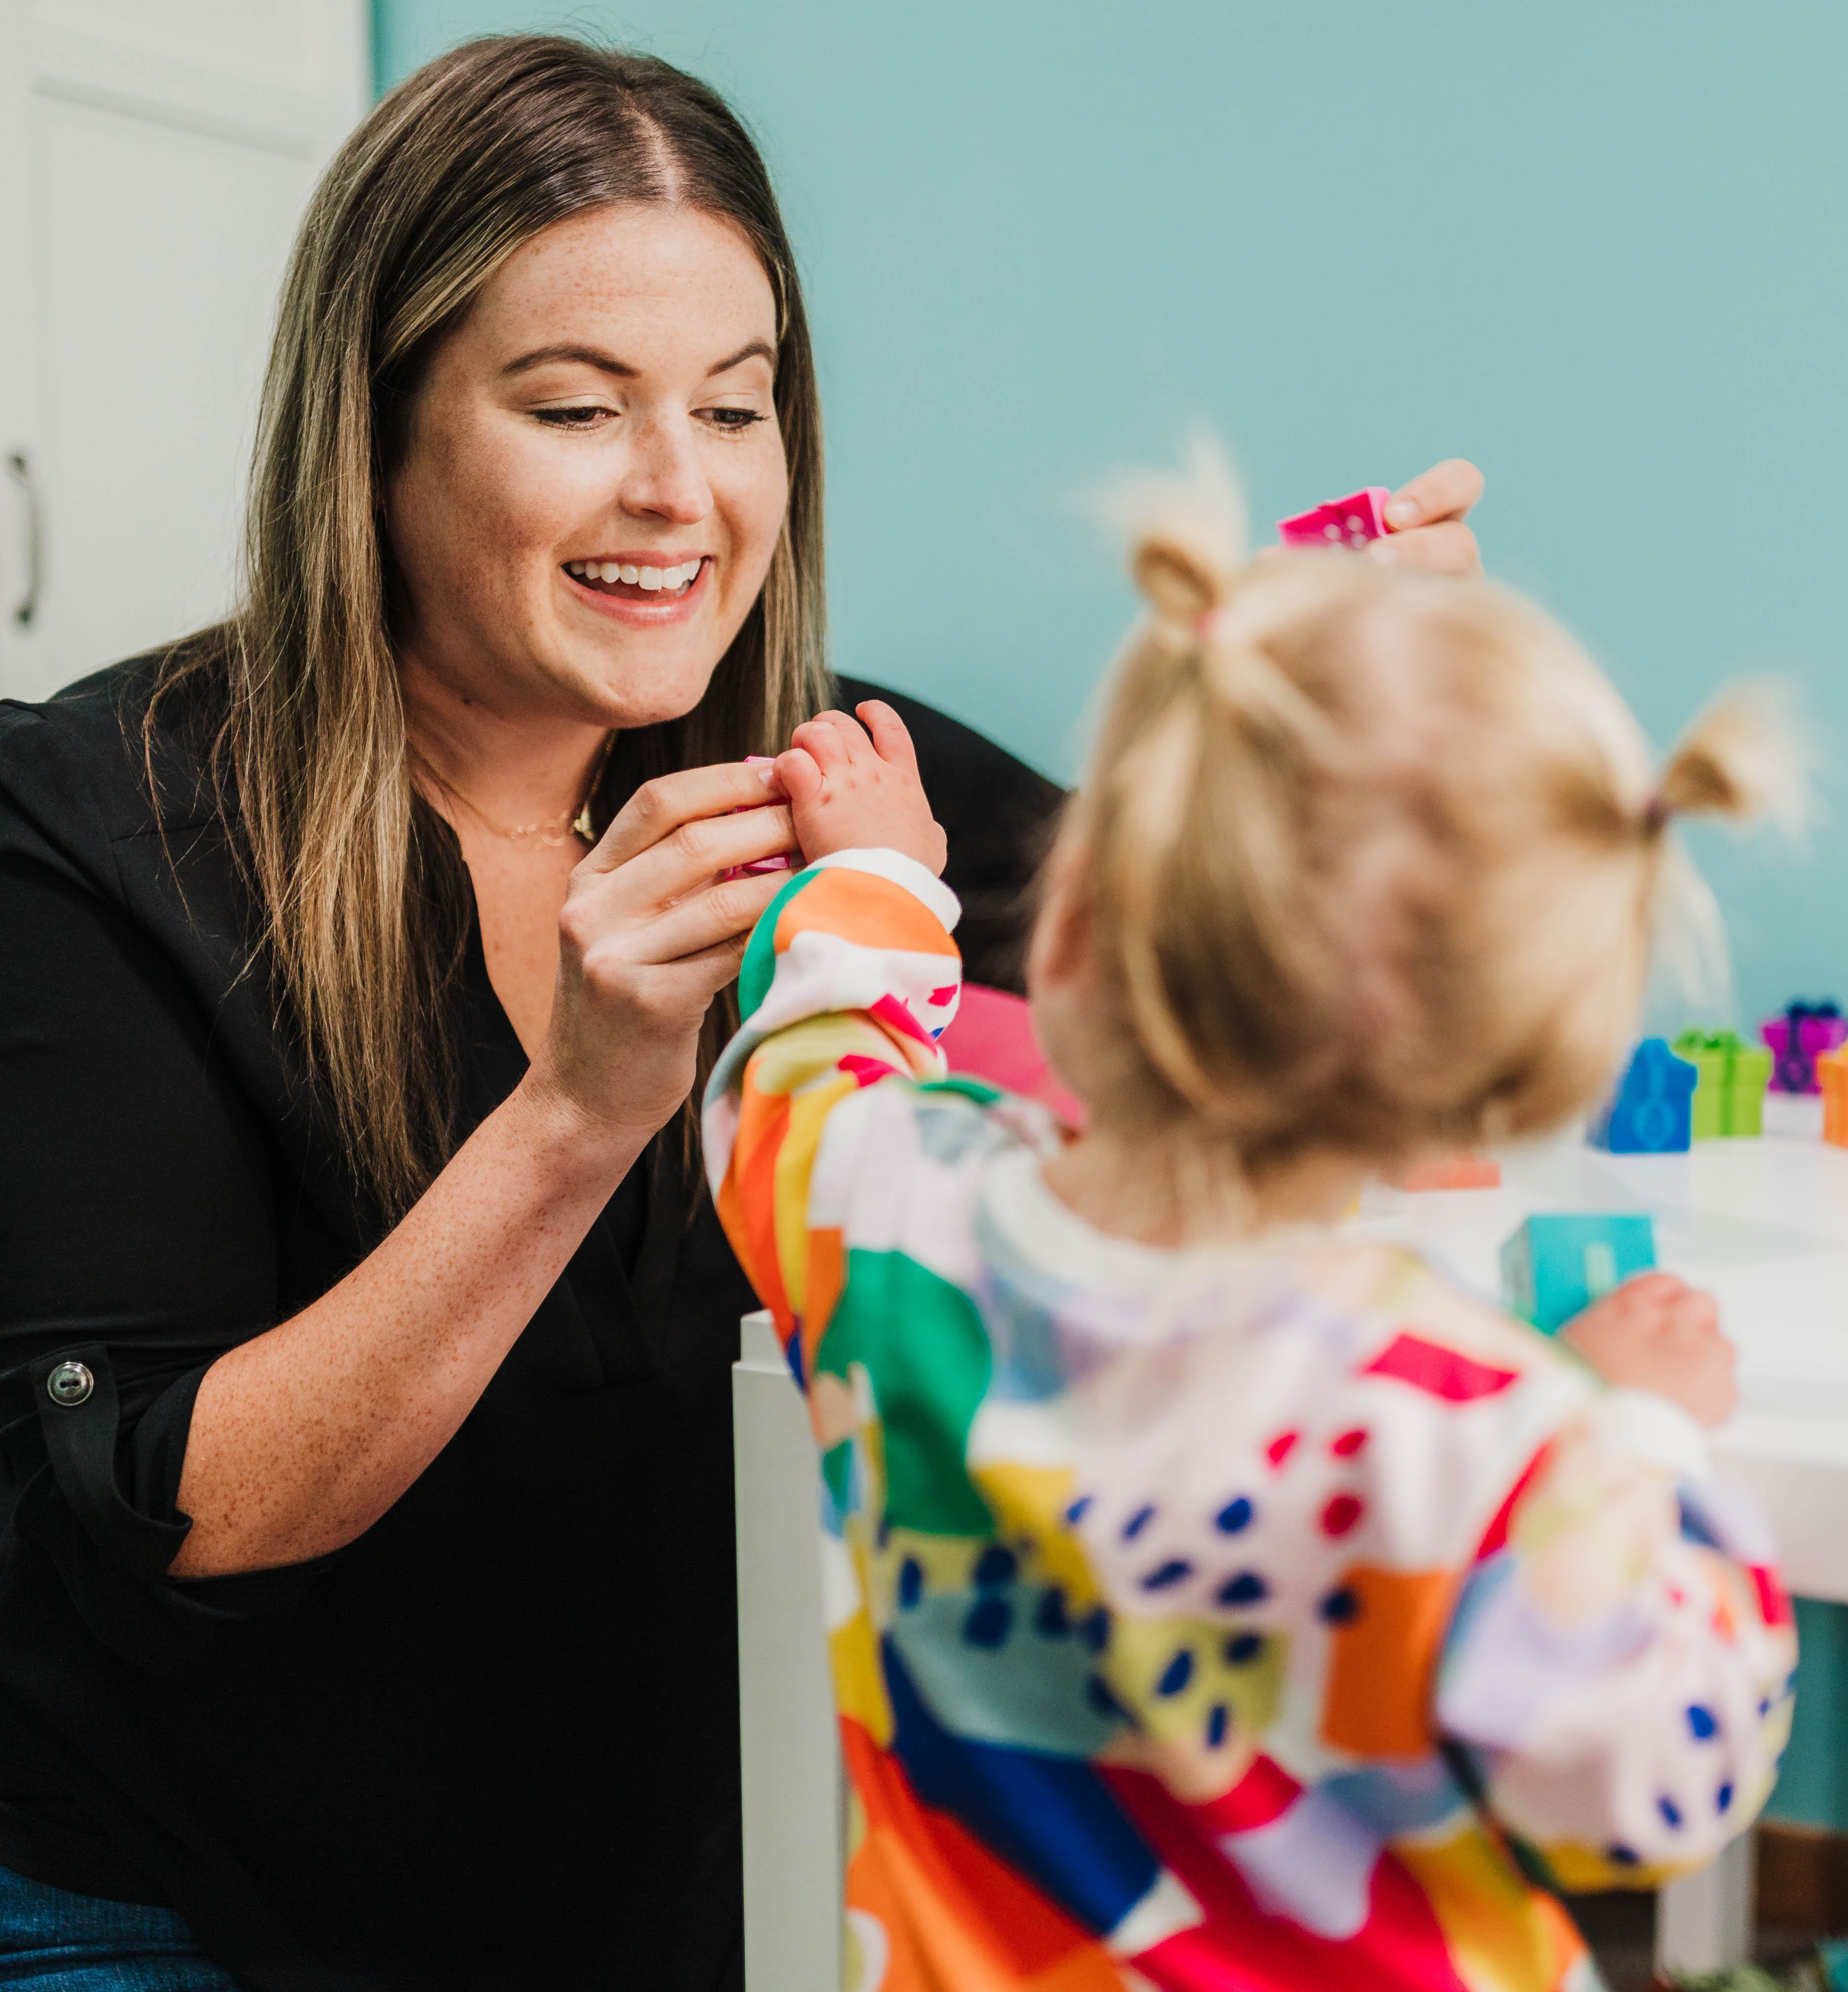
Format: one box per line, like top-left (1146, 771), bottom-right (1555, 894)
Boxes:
top-left (146, 34), bottom-right (828, 1215)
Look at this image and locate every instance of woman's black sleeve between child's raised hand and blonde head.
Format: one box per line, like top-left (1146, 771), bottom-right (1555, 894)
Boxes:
top-left (840, 677), bottom-right (1066, 994)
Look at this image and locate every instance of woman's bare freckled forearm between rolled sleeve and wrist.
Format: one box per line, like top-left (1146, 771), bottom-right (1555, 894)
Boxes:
top-left (173, 1084), bottom-right (647, 1578)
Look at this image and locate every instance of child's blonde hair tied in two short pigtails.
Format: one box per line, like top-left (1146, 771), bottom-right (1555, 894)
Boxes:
top-left (1060, 452), bottom-right (1796, 1177)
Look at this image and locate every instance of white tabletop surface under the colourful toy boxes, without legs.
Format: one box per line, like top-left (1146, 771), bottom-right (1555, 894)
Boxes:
top-left (1352, 1094), bottom-right (1848, 1601)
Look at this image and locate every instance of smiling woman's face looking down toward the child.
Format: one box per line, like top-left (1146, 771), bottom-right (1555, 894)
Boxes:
top-left (387, 203), bottom-right (788, 727)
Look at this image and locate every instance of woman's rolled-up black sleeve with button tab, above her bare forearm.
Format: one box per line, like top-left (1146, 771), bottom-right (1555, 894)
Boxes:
top-left (0, 709), bottom-right (314, 1665)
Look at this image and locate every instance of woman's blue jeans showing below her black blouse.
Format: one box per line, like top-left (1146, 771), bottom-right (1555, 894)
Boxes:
top-left (0, 1869), bottom-right (243, 1992)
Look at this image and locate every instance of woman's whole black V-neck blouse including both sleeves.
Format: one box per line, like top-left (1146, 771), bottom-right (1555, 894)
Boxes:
top-left (0, 659), bottom-right (1058, 1992)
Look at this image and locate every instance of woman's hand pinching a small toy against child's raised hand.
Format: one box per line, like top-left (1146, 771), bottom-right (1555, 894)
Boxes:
top-left (526, 763), bottom-right (794, 1145)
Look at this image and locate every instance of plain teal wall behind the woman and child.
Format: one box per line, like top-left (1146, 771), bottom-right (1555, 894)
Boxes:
top-left (379, 0), bottom-right (1848, 1016)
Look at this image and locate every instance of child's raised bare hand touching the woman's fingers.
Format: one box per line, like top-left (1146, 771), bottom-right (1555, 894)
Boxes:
top-left (777, 699), bottom-right (950, 875)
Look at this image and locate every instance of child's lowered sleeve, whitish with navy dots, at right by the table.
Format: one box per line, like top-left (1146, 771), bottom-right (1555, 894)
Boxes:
top-left (1438, 1391), bottom-right (1796, 1889)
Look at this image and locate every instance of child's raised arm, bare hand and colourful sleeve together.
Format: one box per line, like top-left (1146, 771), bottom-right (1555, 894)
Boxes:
top-left (705, 701), bottom-right (962, 1348)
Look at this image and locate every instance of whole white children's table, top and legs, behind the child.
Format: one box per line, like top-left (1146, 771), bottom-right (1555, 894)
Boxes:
top-left (733, 1096), bottom-right (1848, 1992)
